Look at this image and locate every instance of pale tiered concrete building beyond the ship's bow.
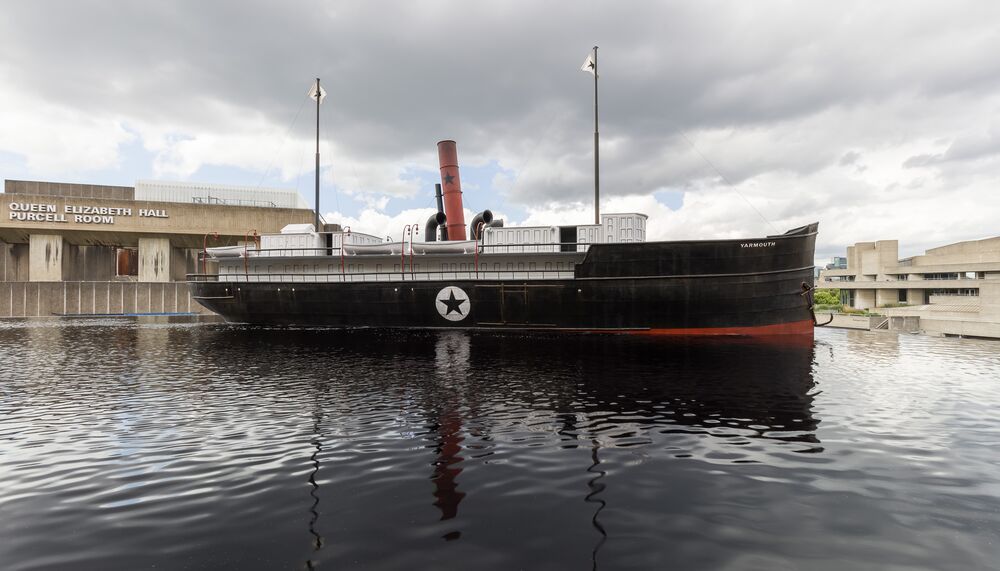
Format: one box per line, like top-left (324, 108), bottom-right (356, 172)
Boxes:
top-left (816, 236), bottom-right (1000, 338)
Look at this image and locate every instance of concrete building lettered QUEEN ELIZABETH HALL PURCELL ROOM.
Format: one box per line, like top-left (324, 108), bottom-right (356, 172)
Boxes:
top-left (0, 180), bottom-right (313, 317)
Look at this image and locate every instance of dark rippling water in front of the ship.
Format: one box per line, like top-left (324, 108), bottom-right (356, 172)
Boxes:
top-left (0, 320), bottom-right (1000, 570)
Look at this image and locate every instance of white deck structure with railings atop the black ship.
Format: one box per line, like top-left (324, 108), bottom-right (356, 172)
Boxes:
top-left (206, 214), bottom-right (647, 283)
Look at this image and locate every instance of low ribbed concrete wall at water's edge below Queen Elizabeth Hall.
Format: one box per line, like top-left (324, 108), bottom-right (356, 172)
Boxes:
top-left (0, 282), bottom-right (211, 317)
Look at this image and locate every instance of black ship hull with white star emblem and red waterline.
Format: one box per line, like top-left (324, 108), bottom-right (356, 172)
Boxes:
top-left (190, 224), bottom-right (817, 335)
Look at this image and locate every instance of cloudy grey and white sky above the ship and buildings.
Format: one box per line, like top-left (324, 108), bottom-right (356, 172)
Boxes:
top-left (0, 0), bottom-right (1000, 261)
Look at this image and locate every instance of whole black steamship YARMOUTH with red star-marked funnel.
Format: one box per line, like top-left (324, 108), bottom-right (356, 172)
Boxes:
top-left (188, 137), bottom-right (819, 338)
